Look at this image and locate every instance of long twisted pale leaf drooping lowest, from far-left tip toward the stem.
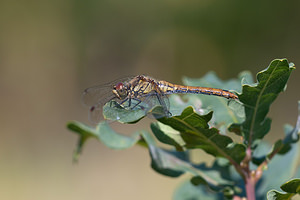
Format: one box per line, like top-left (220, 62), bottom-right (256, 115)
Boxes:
top-left (67, 121), bottom-right (232, 191)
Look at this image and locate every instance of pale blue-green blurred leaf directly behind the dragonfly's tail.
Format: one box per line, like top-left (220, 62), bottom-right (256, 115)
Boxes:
top-left (183, 71), bottom-right (253, 128)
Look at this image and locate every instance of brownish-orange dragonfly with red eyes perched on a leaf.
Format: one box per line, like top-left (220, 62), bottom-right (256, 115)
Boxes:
top-left (82, 75), bottom-right (238, 123)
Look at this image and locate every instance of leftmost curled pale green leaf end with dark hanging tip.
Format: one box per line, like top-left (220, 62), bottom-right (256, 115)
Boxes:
top-left (67, 121), bottom-right (140, 160)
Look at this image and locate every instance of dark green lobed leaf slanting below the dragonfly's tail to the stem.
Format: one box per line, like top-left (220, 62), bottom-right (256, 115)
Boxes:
top-left (158, 107), bottom-right (245, 163)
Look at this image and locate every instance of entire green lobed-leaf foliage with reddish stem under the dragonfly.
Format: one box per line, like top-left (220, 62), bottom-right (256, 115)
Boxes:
top-left (67, 59), bottom-right (300, 200)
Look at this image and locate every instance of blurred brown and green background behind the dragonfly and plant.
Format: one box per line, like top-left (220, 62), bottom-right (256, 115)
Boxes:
top-left (0, 0), bottom-right (300, 200)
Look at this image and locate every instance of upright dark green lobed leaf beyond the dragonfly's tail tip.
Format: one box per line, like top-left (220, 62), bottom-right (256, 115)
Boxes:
top-left (229, 59), bottom-right (295, 145)
